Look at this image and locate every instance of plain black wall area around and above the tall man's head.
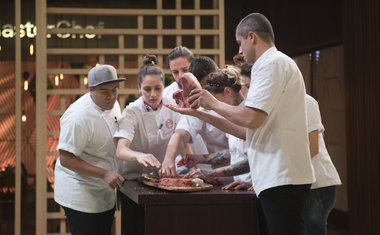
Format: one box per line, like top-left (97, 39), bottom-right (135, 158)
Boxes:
top-left (225, 0), bottom-right (342, 60)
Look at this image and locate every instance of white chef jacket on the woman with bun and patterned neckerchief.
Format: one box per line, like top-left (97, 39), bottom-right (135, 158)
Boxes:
top-left (114, 97), bottom-right (181, 179)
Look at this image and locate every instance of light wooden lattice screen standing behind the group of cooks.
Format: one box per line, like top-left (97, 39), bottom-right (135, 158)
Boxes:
top-left (36, 0), bottom-right (225, 235)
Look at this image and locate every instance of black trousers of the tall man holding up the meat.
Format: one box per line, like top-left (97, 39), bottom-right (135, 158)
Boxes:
top-left (258, 184), bottom-right (310, 235)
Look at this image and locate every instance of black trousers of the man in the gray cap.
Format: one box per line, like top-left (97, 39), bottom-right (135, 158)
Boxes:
top-left (63, 207), bottom-right (115, 235)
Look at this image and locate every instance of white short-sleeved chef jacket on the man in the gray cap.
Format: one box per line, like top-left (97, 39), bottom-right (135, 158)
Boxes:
top-left (54, 93), bottom-right (121, 213)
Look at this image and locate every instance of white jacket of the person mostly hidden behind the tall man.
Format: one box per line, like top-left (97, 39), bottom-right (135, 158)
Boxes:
top-left (306, 95), bottom-right (342, 189)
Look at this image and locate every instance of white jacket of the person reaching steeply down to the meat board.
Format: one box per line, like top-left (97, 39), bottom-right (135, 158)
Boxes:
top-left (176, 109), bottom-right (228, 153)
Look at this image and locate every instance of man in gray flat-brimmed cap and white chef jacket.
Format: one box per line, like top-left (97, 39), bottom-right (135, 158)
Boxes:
top-left (54, 65), bottom-right (125, 235)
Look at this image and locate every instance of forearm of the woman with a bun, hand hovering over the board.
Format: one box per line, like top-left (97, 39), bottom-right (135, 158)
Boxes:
top-left (116, 138), bottom-right (161, 168)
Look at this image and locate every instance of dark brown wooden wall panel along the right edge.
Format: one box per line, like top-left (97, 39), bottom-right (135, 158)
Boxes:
top-left (343, 0), bottom-right (380, 235)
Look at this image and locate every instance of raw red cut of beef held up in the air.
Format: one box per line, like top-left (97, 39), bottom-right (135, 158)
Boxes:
top-left (173, 73), bottom-right (202, 108)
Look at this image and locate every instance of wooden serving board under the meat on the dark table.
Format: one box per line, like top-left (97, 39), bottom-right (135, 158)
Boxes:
top-left (140, 174), bottom-right (213, 192)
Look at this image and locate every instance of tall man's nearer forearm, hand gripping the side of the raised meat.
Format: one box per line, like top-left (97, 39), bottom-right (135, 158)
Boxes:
top-left (189, 89), bottom-right (268, 129)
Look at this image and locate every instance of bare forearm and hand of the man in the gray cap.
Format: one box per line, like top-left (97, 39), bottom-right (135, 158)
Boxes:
top-left (59, 149), bottom-right (124, 189)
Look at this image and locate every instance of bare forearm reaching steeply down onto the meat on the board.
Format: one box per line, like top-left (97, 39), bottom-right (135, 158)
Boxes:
top-left (158, 129), bottom-right (191, 177)
